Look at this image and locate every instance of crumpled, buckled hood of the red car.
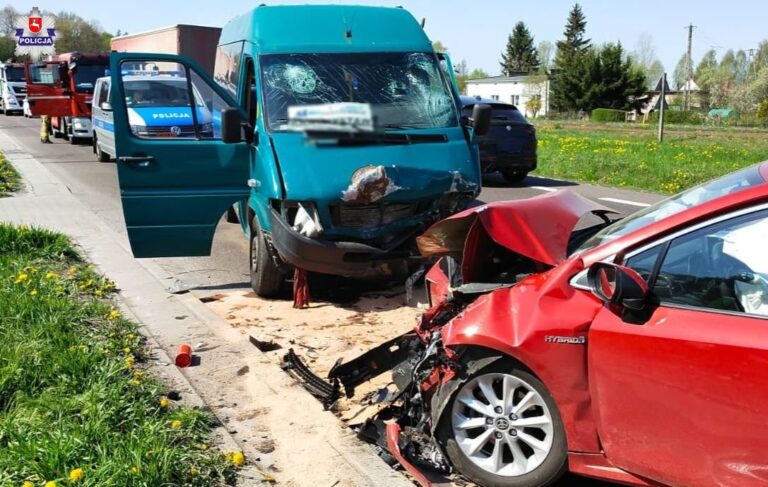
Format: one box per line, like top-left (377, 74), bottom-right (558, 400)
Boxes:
top-left (416, 189), bottom-right (615, 273)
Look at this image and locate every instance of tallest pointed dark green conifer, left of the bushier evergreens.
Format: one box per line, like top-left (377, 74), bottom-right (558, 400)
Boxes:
top-left (551, 3), bottom-right (595, 111)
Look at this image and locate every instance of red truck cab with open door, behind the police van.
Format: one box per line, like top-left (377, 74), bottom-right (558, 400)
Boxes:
top-left (25, 52), bottom-right (109, 143)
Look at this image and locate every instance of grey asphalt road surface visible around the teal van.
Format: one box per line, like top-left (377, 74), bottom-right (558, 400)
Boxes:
top-left (0, 115), bottom-right (661, 487)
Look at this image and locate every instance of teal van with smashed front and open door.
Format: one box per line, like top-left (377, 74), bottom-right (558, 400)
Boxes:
top-left (110, 5), bottom-right (490, 296)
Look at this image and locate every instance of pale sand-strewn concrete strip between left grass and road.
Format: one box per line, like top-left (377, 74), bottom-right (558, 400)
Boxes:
top-left (0, 133), bottom-right (413, 487)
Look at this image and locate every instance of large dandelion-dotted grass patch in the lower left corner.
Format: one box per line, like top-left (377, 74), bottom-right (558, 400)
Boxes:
top-left (0, 223), bottom-right (242, 487)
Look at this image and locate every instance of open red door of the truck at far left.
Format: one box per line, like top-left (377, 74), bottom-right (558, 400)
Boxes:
top-left (24, 62), bottom-right (72, 117)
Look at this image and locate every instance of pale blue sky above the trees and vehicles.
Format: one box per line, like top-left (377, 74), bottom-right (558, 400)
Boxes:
top-left (12, 0), bottom-right (768, 76)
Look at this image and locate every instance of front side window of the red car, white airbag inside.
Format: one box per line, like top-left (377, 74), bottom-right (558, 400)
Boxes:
top-left (652, 211), bottom-right (768, 316)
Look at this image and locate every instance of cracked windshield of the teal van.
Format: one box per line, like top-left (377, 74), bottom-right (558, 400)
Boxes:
top-left (260, 53), bottom-right (458, 130)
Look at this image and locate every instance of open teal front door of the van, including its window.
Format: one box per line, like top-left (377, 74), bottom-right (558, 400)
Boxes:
top-left (110, 53), bottom-right (250, 257)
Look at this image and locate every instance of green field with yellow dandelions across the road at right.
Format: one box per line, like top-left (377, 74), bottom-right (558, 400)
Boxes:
top-left (535, 122), bottom-right (768, 194)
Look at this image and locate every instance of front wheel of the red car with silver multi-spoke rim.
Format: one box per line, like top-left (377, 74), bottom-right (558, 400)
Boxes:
top-left (435, 360), bottom-right (568, 487)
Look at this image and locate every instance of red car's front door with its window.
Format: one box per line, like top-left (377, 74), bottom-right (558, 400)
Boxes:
top-left (588, 210), bottom-right (768, 486)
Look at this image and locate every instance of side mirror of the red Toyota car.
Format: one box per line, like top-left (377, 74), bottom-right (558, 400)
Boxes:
top-left (587, 262), bottom-right (649, 311)
